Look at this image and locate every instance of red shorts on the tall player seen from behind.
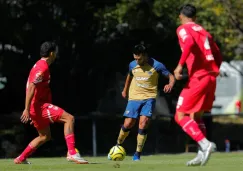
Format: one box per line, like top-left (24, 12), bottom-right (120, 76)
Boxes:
top-left (176, 75), bottom-right (216, 114)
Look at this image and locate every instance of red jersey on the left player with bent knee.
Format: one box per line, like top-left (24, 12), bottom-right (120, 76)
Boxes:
top-left (26, 59), bottom-right (52, 112)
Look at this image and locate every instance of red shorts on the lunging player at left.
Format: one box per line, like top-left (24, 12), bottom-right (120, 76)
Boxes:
top-left (30, 103), bottom-right (64, 130)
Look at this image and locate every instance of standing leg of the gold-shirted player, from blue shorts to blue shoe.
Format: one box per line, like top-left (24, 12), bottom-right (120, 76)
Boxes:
top-left (133, 99), bottom-right (156, 161)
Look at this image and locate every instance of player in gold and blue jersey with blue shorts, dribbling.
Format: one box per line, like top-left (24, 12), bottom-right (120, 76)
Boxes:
top-left (114, 44), bottom-right (175, 161)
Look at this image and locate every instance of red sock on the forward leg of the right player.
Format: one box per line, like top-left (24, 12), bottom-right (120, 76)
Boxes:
top-left (179, 116), bottom-right (205, 142)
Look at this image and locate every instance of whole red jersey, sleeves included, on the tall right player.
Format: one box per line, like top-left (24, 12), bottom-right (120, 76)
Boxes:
top-left (177, 22), bottom-right (222, 78)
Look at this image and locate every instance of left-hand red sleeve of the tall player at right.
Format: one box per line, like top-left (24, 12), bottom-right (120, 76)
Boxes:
top-left (177, 28), bottom-right (194, 66)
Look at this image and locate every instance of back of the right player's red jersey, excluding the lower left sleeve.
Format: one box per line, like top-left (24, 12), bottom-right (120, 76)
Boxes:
top-left (177, 22), bottom-right (219, 77)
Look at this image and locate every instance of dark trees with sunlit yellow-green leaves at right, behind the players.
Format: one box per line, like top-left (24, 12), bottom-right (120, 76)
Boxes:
top-left (0, 0), bottom-right (243, 113)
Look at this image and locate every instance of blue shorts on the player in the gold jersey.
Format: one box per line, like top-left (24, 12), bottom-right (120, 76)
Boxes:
top-left (123, 99), bottom-right (156, 119)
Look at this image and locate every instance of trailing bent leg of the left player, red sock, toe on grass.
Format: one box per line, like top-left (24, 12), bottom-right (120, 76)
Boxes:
top-left (14, 126), bottom-right (51, 164)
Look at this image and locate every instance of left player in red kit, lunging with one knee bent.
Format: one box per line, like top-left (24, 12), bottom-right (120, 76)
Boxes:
top-left (14, 42), bottom-right (88, 164)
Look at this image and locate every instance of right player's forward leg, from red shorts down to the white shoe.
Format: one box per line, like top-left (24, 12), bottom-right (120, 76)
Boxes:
top-left (175, 77), bottom-right (215, 164)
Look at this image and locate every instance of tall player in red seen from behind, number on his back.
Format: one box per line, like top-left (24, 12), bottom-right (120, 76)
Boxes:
top-left (174, 4), bottom-right (222, 166)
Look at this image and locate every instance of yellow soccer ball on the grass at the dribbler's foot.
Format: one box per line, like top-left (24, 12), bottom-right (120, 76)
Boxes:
top-left (108, 145), bottom-right (126, 161)
